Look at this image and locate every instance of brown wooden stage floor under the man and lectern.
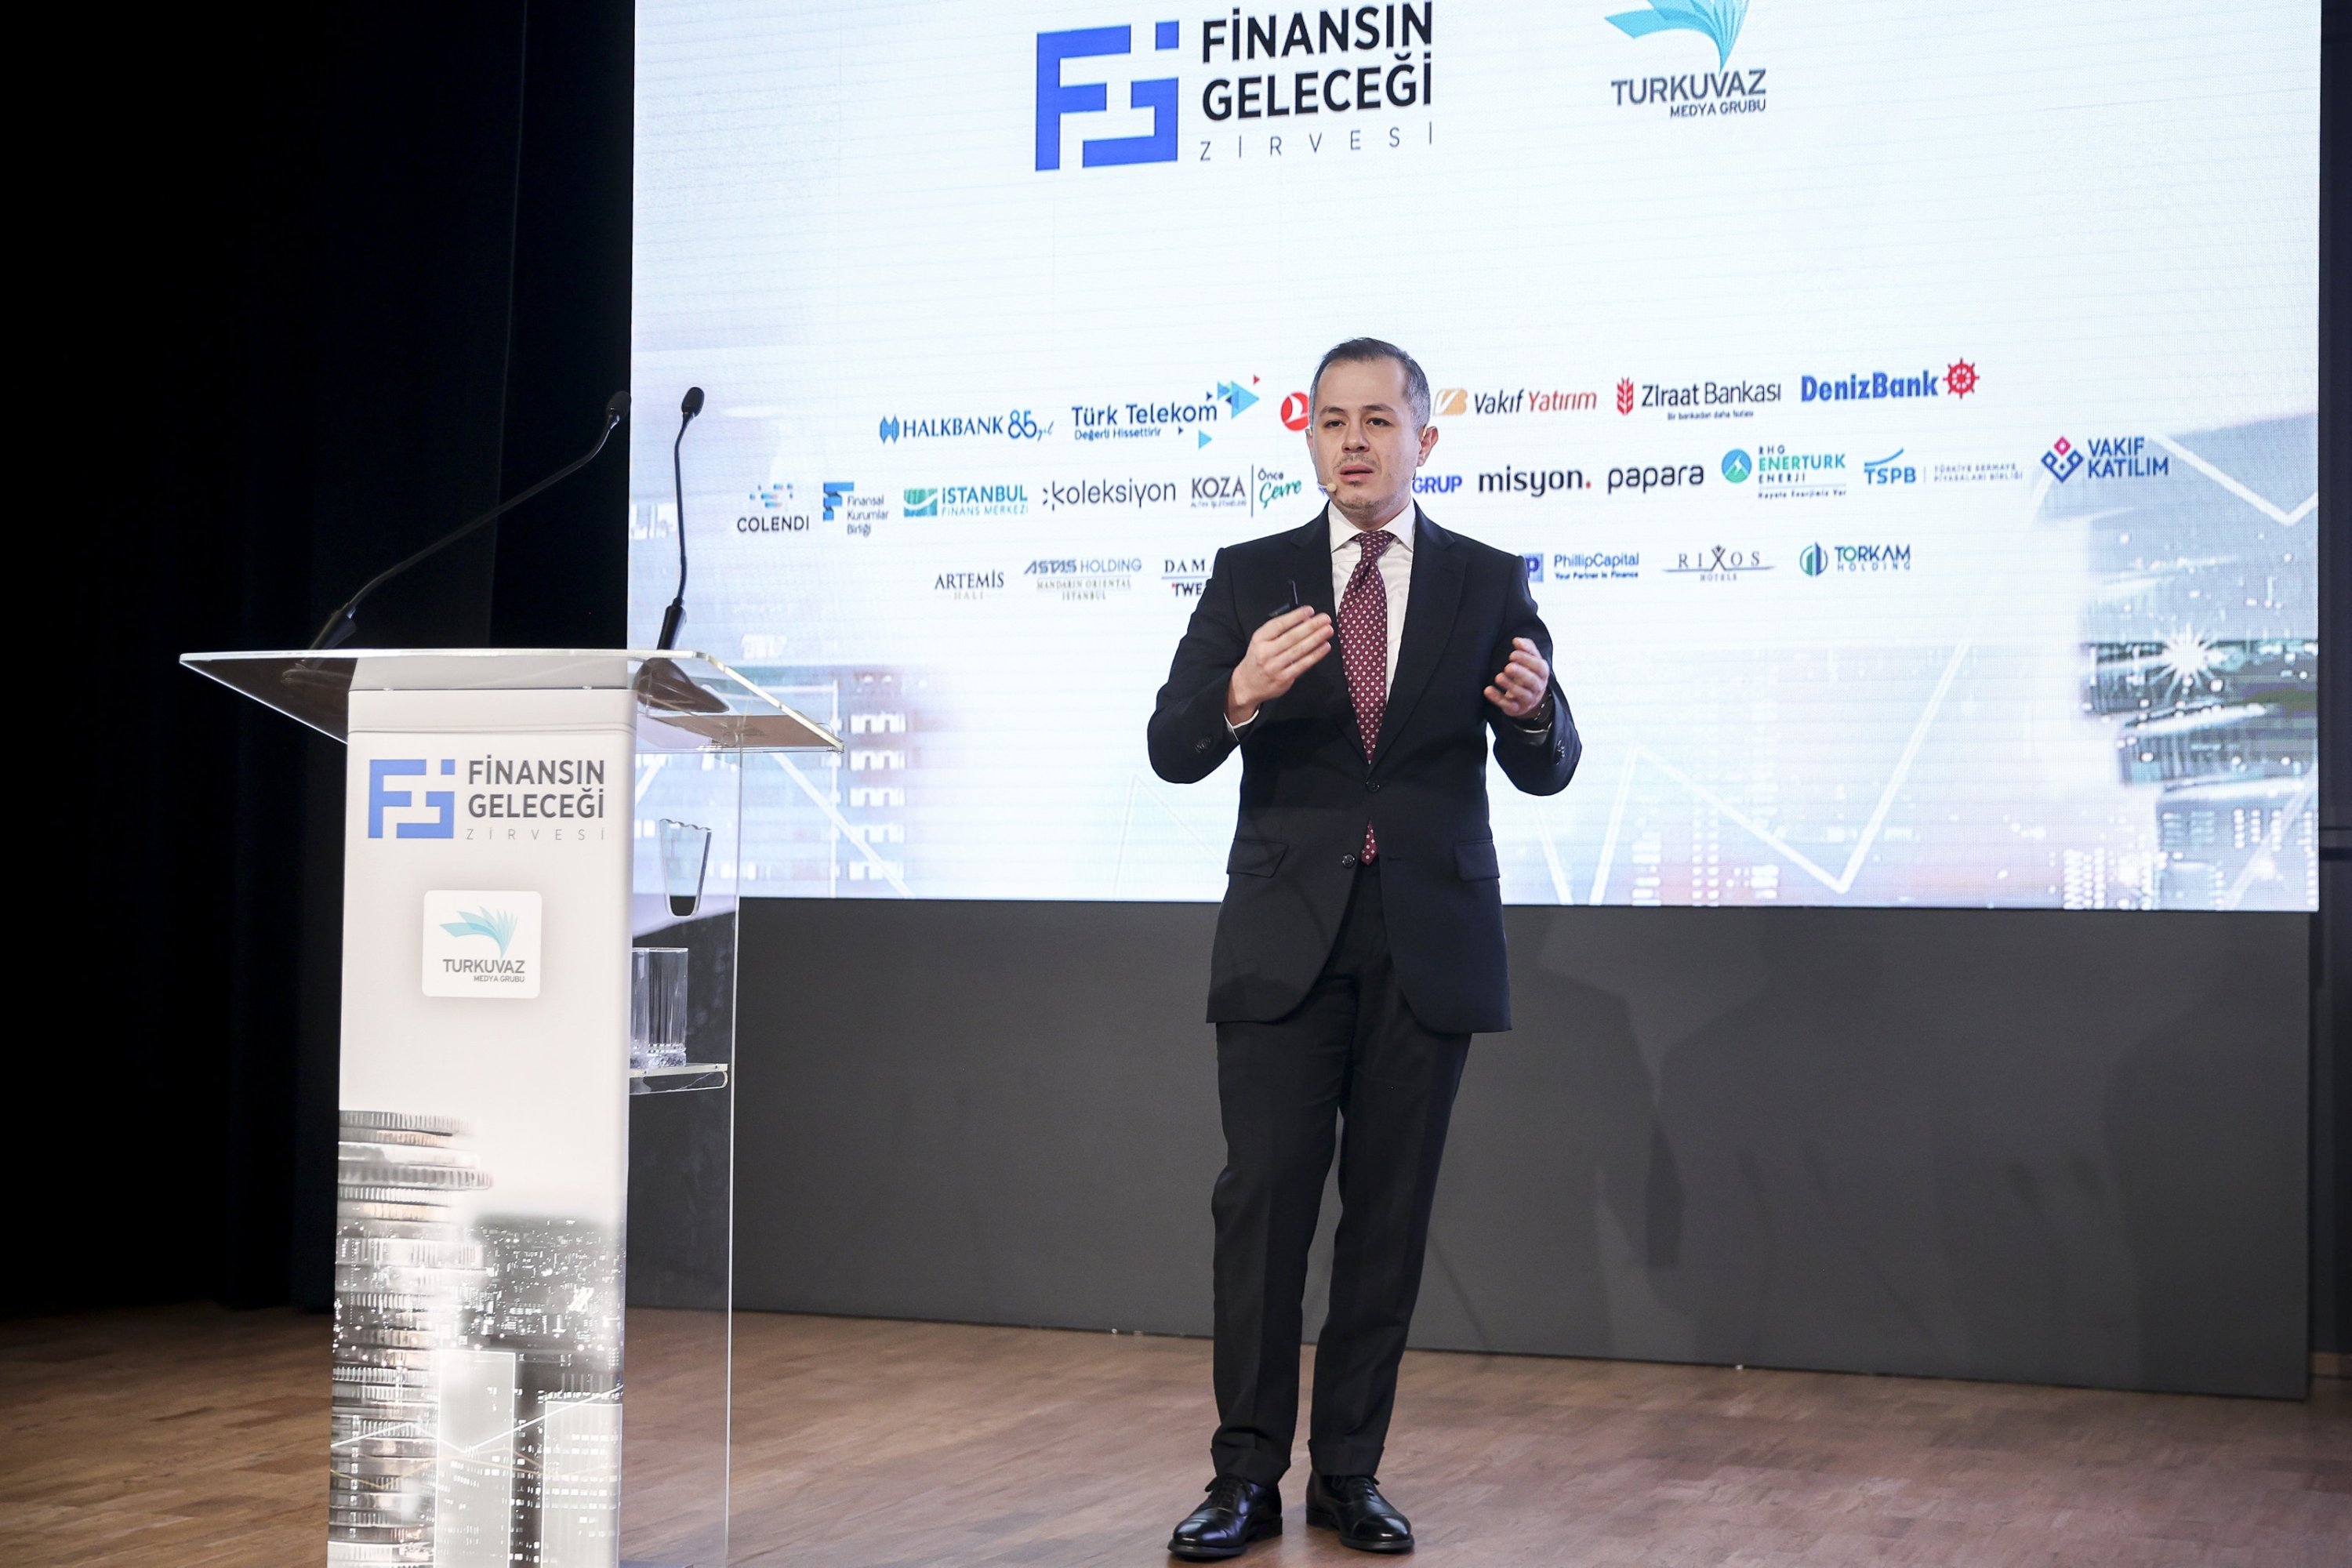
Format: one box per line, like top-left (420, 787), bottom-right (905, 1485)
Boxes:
top-left (0, 1307), bottom-right (2352, 1568)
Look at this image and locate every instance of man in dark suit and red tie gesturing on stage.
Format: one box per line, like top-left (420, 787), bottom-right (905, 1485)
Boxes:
top-left (1150, 339), bottom-right (1581, 1561)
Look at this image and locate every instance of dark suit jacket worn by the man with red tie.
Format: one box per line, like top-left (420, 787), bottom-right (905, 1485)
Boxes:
top-left (1150, 506), bottom-right (1583, 1034)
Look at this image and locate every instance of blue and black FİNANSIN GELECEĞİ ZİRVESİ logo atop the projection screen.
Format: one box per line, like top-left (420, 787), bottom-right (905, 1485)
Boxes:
top-left (1035, 0), bottom-right (1437, 172)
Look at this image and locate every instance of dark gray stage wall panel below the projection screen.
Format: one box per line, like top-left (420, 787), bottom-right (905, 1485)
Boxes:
top-left (724, 900), bottom-right (2310, 1396)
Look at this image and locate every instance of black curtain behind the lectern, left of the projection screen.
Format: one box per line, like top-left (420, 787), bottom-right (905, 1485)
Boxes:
top-left (25, 0), bottom-right (633, 1309)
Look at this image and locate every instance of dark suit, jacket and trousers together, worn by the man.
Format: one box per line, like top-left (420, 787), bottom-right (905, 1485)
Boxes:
top-left (1150, 508), bottom-right (1581, 1483)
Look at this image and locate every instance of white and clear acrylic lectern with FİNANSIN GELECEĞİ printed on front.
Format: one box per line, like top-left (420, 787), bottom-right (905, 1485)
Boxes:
top-left (183, 649), bottom-right (842, 1568)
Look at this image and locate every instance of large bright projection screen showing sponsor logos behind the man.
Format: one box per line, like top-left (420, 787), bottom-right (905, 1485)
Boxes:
top-left (630, 0), bottom-right (2319, 909)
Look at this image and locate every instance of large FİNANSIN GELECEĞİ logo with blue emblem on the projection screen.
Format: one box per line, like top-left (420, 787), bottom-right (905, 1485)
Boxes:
top-left (1033, 0), bottom-right (1437, 174)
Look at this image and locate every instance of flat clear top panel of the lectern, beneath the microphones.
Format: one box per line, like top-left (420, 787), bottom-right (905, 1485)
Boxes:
top-left (181, 649), bottom-right (842, 753)
